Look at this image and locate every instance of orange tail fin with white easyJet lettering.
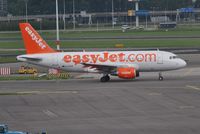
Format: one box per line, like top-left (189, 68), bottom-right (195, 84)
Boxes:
top-left (19, 23), bottom-right (56, 54)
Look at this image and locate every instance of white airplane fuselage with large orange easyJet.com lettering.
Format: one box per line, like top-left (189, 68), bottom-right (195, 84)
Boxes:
top-left (17, 51), bottom-right (186, 73)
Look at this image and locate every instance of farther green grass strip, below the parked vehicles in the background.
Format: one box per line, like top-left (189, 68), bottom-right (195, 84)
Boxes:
top-left (0, 25), bottom-right (200, 39)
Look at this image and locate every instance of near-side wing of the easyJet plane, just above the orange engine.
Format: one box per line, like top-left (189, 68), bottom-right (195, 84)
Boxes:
top-left (81, 63), bottom-right (138, 73)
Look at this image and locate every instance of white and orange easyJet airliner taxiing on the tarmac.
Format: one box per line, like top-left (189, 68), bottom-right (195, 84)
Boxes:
top-left (17, 23), bottom-right (186, 82)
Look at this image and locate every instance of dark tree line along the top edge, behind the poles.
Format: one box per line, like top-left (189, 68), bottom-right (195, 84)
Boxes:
top-left (8, 0), bottom-right (200, 15)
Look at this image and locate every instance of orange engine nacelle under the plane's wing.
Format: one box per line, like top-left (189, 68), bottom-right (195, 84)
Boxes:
top-left (117, 67), bottom-right (139, 79)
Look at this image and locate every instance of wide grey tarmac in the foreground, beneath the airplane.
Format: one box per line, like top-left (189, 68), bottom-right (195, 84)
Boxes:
top-left (0, 65), bottom-right (200, 134)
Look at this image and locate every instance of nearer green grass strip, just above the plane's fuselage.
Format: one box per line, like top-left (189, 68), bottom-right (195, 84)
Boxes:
top-left (0, 39), bottom-right (200, 49)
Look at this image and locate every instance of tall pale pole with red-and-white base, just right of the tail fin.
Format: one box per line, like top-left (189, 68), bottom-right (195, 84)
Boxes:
top-left (56, 0), bottom-right (60, 50)
